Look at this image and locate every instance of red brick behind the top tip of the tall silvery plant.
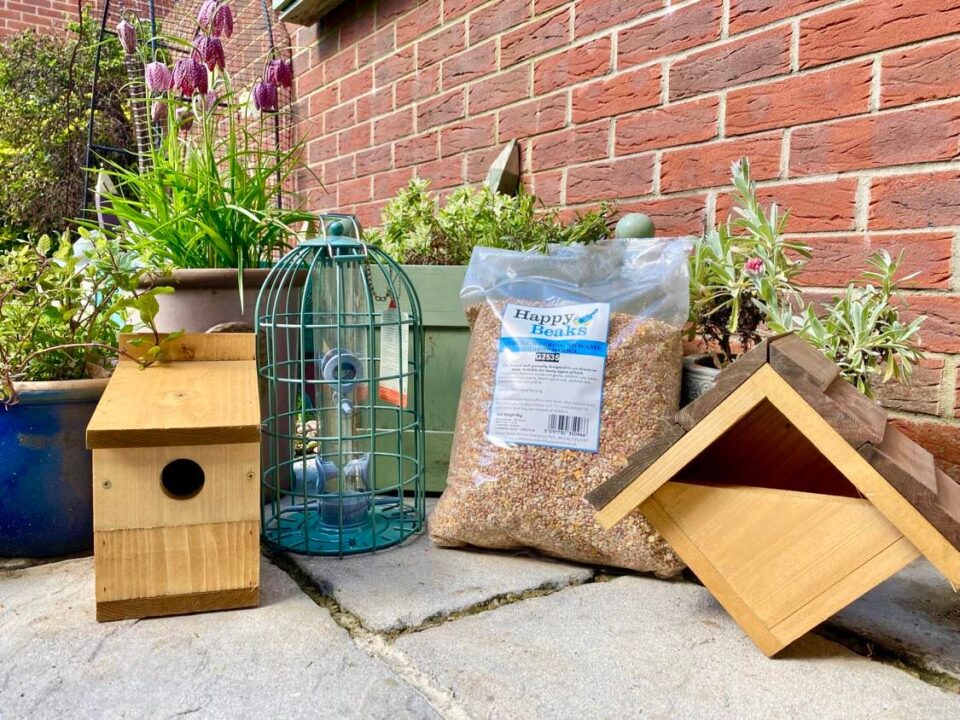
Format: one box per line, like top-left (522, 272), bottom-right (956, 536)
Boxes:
top-left (660, 133), bottom-right (780, 193)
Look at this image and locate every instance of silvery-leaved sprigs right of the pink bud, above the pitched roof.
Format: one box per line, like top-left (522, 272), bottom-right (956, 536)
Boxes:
top-left (768, 250), bottom-right (926, 397)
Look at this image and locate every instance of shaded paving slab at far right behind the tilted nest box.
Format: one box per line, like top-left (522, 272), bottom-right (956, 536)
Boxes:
top-left (827, 559), bottom-right (960, 680)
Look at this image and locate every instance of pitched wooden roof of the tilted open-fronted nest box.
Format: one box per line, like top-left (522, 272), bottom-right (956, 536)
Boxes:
top-left (587, 335), bottom-right (960, 586)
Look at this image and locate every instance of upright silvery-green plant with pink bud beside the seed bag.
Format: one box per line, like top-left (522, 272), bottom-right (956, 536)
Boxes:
top-left (688, 158), bottom-right (810, 368)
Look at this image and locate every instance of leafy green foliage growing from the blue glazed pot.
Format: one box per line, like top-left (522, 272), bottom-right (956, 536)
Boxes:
top-left (0, 229), bottom-right (171, 404)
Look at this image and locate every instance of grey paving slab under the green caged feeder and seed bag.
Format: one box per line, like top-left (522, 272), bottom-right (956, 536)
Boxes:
top-left (289, 533), bottom-right (593, 632)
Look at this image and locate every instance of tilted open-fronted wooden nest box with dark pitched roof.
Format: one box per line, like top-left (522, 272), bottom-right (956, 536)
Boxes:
top-left (589, 335), bottom-right (960, 655)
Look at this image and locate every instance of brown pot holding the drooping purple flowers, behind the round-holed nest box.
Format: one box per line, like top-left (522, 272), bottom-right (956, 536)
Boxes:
top-left (141, 268), bottom-right (270, 332)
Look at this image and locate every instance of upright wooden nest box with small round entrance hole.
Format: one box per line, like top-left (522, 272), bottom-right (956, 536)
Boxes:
top-left (87, 334), bottom-right (260, 621)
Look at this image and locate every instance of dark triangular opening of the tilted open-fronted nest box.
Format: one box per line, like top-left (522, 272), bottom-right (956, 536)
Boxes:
top-left (674, 400), bottom-right (861, 498)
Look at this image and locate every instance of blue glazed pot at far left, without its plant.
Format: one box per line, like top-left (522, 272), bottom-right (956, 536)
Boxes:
top-left (0, 379), bottom-right (107, 557)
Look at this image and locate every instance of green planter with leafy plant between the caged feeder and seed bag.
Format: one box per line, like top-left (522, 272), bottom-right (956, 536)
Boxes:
top-left (367, 180), bottom-right (612, 491)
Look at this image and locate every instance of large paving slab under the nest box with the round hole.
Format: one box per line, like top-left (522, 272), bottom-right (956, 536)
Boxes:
top-left (0, 558), bottom-right (437, 720)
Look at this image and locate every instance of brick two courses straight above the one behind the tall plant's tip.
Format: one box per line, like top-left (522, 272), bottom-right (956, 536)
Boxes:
top-left (670, 28), bottom-right (790, 100)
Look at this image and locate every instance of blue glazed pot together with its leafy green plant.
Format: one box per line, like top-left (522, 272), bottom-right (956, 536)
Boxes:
top-left (0, 231), bottom-right (164, 557)
